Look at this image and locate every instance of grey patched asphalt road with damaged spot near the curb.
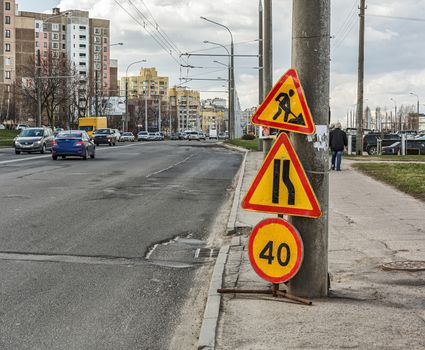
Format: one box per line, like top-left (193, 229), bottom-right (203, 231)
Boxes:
top-left (0, 141), bottom-right (241, 350)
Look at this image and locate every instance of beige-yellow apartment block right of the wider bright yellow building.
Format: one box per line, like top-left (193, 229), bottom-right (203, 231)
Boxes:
top-left (168, 86), bottom-right (201, 131)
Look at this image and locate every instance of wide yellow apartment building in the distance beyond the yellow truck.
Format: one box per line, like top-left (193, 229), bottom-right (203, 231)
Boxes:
top-left (120, 67), bottom-right (168, 100)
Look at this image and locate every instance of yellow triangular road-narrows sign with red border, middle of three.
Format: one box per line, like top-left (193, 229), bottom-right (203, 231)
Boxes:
top-left (242, 133), bottom-right (322, 218)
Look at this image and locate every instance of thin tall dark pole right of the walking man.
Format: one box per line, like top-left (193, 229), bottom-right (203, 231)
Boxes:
top-left (356, 0), bottom-right (366, 156)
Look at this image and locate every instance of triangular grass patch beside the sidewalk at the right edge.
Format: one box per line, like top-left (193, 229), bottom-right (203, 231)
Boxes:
top-left (352, 163), bottom-right (425, 202)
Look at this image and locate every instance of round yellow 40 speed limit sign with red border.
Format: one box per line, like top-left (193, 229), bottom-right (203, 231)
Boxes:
top-left (248, 218), bottom-right (304, 283)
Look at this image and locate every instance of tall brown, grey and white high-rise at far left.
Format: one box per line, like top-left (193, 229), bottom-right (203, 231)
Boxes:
top-left (0, 4), bottom-right (112, 120)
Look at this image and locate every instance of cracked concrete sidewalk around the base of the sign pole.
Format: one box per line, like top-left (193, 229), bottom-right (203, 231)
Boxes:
top-left (202, 152), bottom-right (425, 349)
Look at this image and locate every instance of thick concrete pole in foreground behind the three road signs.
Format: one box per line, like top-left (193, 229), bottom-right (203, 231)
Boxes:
top-left (288, 0), bottom-right (330, 297)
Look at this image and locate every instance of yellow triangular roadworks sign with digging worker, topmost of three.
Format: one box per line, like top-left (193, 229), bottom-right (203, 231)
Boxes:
top-left (252, 69), bottom-right (314, 134)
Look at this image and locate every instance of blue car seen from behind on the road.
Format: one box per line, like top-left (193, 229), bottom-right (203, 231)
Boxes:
top-left (52, 130), bottom-right (96, 160)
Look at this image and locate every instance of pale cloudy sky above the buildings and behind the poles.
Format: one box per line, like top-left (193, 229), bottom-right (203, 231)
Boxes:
top-left (18, 0), bottom-right (425, 124)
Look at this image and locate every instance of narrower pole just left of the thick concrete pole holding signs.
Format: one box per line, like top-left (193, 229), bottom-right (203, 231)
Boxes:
top-left (261, 0), bottom-right (273, 156)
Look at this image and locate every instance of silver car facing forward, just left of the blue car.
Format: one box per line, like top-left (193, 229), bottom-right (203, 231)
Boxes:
top-left (13, 127), bottom-right (54, 154)
